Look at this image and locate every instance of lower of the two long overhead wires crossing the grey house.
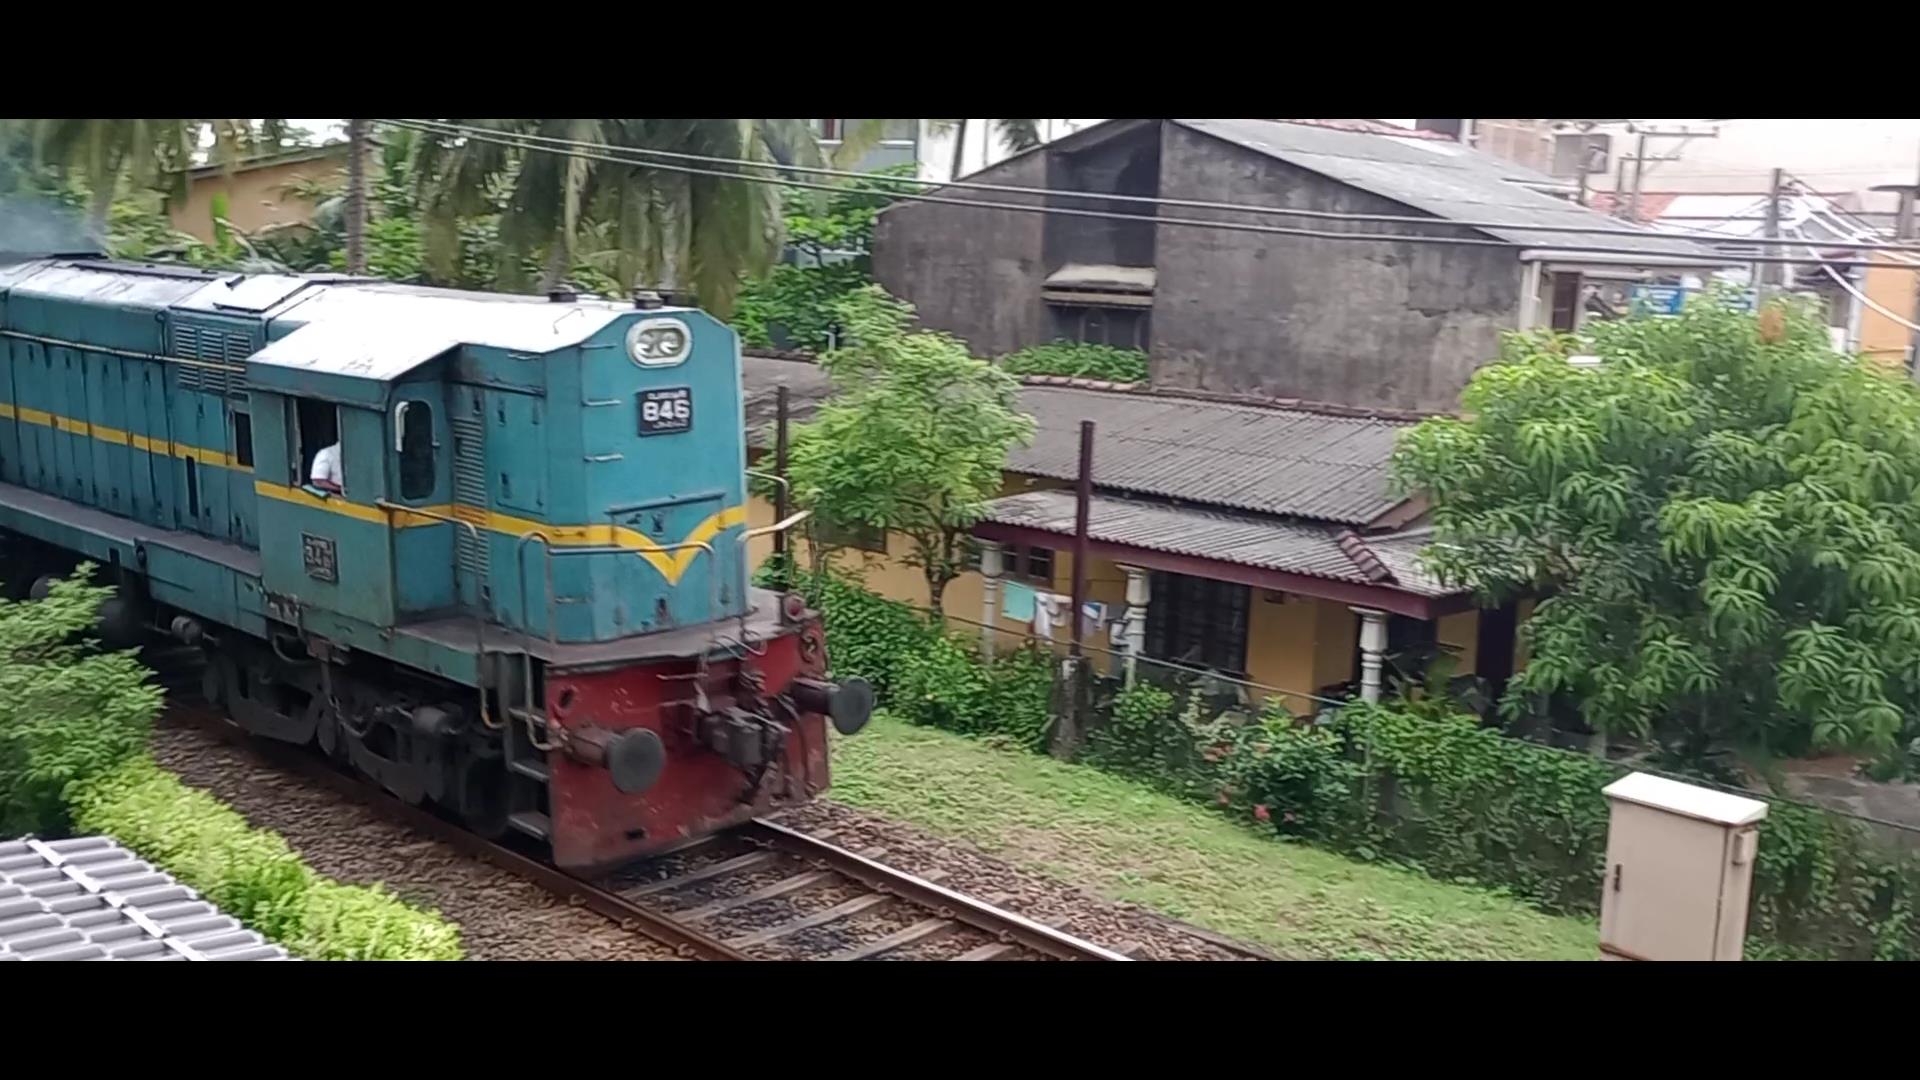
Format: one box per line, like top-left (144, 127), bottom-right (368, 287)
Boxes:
top-left (374, 119), bottom-right (1920, 269)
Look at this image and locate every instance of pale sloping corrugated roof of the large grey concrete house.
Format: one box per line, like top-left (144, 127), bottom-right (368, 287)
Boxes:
top-left (1173, 119), bottom-right (1713, 259)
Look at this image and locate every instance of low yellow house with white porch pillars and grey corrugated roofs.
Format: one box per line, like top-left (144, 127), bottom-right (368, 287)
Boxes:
top-left (743, 356), bottom-right (1517, 713)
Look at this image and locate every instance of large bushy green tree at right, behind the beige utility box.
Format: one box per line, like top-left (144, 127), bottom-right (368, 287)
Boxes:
top-left (1394, 294), bottom-right (1920, 755)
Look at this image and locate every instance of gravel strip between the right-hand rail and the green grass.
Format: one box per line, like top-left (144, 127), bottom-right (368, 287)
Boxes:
top-left (776, 799), bottom-right (1256, 961)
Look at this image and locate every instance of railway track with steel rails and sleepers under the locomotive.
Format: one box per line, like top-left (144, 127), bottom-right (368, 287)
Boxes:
top-left (161, 671), bottom-right (1131, 961)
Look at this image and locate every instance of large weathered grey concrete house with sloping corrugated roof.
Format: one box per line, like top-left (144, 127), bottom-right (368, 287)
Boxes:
top-left (874, 119), bottom-right (1726, 409)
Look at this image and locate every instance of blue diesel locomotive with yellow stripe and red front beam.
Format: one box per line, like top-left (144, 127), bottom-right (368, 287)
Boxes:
top-left (0, 258), bottom-right (872, 869)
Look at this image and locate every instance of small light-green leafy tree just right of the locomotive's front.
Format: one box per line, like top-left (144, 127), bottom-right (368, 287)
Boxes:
top-left (789, 284), bottom-right (1033, 611)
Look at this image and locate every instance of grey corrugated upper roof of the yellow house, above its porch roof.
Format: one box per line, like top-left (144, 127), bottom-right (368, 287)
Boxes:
top-left (743, 356), bottom-right (1417, 525)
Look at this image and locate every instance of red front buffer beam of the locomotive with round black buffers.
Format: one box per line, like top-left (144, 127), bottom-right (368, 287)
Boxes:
top-left (547, 596), bottom-right (872, 869)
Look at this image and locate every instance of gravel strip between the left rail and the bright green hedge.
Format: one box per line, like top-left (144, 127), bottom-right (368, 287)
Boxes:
top-left (154, 721), bottom-right (678, 961)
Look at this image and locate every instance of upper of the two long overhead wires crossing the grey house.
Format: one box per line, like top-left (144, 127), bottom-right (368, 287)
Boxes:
top-left (374, 119), bottom-right (1920, 252)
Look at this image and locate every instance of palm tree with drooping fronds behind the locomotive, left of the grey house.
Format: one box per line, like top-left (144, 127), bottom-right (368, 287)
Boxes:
top-left (413, 119), bottom-right (820, 317)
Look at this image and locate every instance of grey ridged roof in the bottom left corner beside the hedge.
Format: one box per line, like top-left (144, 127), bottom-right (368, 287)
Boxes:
top-left (0, 836), bottom-right (288, 961)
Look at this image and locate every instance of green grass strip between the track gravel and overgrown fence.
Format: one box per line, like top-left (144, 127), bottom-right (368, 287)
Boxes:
top-left (831, 713), bottom-right (1597, 959)
